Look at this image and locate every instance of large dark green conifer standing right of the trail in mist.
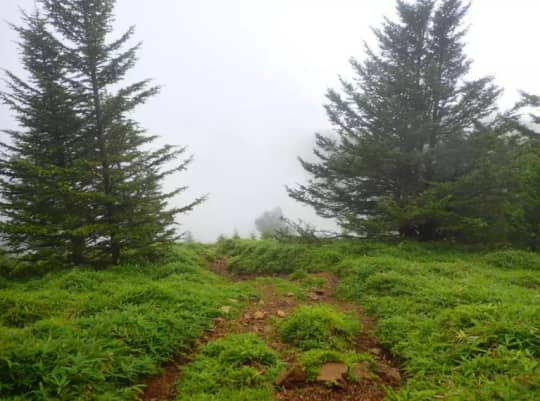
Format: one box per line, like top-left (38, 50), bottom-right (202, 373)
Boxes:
top-left (288, 0), bottom-right (499, 239)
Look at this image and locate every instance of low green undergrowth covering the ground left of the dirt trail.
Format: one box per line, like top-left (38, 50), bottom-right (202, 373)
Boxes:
top-left (0, 246), bottom-right (250, 401)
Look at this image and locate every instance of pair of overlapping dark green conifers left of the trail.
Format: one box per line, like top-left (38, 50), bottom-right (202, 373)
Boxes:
top-left (1, 0), bottom-right (204, 264)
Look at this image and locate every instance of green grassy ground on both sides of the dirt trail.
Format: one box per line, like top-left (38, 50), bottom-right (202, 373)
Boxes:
top-left (0, 241), bottom-right (540, 401)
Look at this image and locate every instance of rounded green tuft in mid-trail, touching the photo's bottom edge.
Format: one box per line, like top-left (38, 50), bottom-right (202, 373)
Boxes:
top-left (177, 333), bottom-right (283, 401)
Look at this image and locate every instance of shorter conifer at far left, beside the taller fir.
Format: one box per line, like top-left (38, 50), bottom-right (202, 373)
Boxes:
top-left (0, 13), bottom-right (91, 263)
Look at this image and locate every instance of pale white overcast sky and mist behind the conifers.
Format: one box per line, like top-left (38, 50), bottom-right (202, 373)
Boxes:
top-left (0, 0), bottom-right (540, 241)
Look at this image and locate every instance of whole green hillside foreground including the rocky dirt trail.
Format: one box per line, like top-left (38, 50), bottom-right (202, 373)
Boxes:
top-left (0, 240), bottom-right (540, 401)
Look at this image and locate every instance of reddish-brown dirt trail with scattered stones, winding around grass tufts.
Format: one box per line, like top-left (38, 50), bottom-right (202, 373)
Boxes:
top-left (140, 259), bottom-right (400, 401)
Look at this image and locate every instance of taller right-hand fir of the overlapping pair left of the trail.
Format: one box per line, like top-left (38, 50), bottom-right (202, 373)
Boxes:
top-left (42, 0), bottom-right (204, 264)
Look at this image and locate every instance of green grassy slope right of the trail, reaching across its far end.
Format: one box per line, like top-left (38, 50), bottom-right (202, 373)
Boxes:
top-left (218, 241), bottom-right (540, 401)
